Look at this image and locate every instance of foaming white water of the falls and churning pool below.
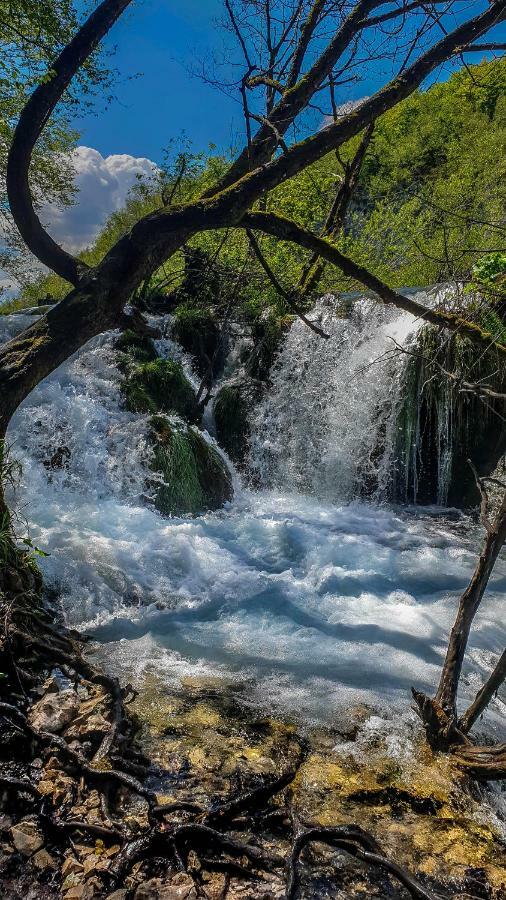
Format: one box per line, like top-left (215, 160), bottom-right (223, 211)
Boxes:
top-left (0, 304), bottom-right (506, 729)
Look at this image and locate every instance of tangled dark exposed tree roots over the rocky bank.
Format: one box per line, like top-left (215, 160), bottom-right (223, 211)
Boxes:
top-left (0, 548), bottom-right (505, 900)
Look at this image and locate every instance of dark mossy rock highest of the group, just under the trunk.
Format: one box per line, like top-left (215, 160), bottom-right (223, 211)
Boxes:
top-left (172, 303), bottom-right (224, 376)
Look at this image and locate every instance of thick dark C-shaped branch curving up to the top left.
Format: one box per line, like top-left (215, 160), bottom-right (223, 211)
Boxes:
top-left (7, 0), bottom-right (131, 285)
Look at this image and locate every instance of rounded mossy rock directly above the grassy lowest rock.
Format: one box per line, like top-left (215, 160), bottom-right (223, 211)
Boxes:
top-left (122, 359), bottom-right (201, 423)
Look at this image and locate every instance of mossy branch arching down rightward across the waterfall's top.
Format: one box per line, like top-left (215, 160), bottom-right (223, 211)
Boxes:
top-left (239, 212), bottom-right (506, 356)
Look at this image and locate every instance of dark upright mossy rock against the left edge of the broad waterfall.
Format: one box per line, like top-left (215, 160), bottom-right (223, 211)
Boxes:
top-left (214, 379), bottom-right (261, 467)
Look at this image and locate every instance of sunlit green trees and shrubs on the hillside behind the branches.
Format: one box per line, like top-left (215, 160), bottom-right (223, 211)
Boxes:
top-left (6, 60), bottom-right (506, 326)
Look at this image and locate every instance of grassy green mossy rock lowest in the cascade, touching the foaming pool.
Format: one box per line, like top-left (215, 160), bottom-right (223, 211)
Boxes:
top-left (147, 416), bottom-right (233, 516)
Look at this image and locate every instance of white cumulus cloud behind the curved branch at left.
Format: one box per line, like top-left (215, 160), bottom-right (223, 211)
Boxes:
top-left (41, 147), bottom-right (157, 252)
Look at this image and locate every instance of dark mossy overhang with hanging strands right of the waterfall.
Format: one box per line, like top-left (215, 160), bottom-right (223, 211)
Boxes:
top-left (395, 325), bottom-right (506, 507)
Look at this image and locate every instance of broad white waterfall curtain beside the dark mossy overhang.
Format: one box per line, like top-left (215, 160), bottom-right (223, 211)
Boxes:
top-left (250, 293), bottom-right (427, 501)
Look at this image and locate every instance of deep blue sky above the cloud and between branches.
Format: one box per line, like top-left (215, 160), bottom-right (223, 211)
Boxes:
top-left (76, 0), bottom-right (505, 162)
